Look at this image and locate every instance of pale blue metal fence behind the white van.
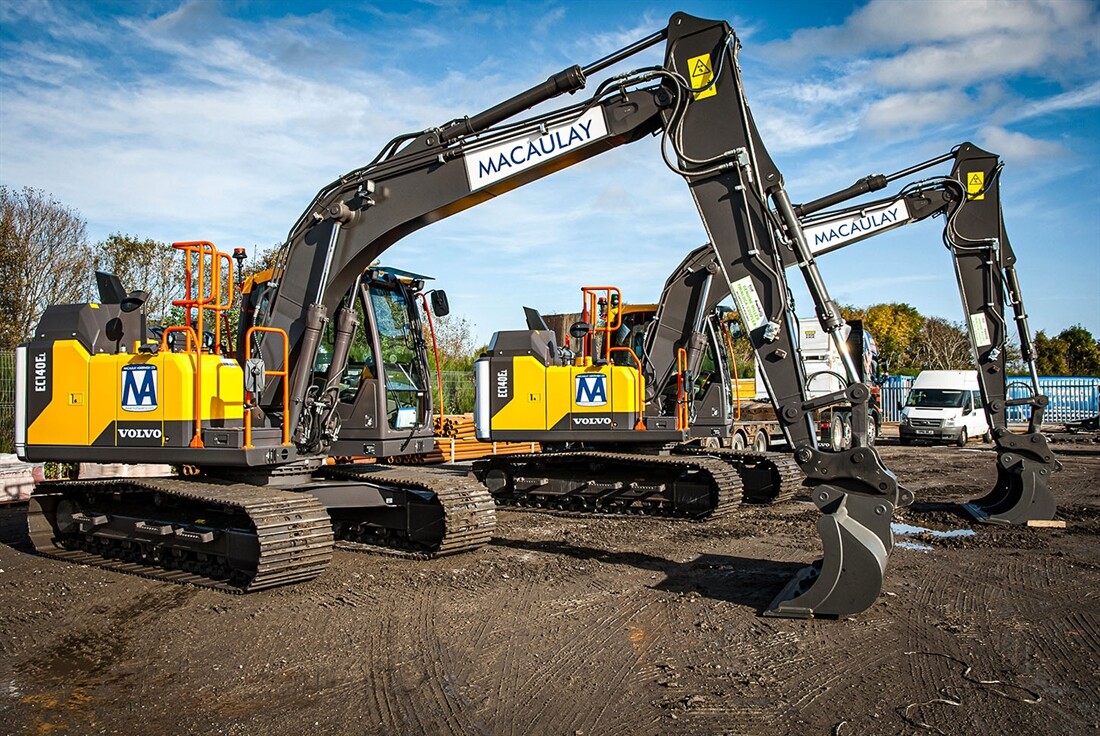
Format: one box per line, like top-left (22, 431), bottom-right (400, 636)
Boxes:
top-left (882, 375), bottom-right (1100, 424)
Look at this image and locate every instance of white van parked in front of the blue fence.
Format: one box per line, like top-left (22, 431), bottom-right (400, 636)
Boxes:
top-left (898, 371), bottom-right (992, 447)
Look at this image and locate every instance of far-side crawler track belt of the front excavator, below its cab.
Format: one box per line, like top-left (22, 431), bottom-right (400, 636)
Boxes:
top-left (321, 464), bottom-right (496, 559)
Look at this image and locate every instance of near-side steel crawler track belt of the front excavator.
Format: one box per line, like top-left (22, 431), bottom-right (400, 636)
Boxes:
top-left (28, 479), bottom-right (333, 593)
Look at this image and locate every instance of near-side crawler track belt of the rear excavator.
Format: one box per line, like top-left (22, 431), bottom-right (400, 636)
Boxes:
top-left (479, 451), bottom-right (743, 519)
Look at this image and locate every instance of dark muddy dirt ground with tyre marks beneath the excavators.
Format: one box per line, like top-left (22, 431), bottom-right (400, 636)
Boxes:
top-left (0, 431), bottom-right (1100, 736)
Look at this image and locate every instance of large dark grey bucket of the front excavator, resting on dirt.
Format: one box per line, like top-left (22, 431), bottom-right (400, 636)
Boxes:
top-left (765, 484), bottom-right (912, 618)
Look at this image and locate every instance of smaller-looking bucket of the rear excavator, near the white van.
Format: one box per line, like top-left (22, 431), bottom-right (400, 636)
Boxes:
top-left (963, 442), bottom-right (1062, 525)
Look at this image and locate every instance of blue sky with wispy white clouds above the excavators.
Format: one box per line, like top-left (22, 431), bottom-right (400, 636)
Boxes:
top-left (0, 0), bottom-right (1100, 340)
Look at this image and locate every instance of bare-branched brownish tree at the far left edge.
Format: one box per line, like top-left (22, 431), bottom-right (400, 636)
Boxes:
top-left (0, 186), bottom-right (91, 350)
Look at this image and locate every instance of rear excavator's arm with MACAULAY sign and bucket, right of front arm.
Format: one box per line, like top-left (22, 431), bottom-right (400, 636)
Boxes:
top-left (784, 143), bottom-right (1060, 524)
